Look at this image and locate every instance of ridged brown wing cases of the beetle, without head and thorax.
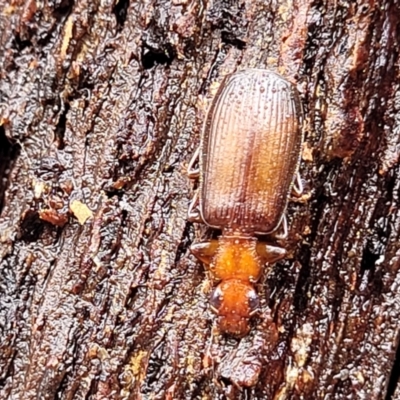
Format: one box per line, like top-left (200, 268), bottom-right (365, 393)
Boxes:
top-left (200, 69), bottom-right (302, 233)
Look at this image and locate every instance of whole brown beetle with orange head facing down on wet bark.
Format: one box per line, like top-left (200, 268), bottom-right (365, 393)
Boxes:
top-left (188, 69), bottom-right (302, 337)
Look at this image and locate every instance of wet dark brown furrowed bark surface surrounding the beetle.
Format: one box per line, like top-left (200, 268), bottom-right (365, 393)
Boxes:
top-left (0, 0), bottom-right (400, 400)
